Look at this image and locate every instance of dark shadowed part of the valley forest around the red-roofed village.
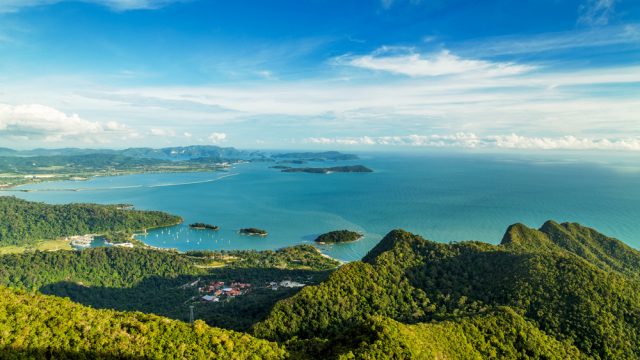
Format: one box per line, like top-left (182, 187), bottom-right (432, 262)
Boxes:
top-left (39, 268), bottom-right (327, 331)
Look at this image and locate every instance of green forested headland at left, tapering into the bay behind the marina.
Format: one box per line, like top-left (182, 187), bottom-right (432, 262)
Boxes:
top-left (0, 196), bottom-right (182, 246)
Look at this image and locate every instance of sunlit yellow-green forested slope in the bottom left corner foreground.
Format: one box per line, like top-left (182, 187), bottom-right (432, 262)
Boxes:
top-left (0, 288), bottom-right (286, 359)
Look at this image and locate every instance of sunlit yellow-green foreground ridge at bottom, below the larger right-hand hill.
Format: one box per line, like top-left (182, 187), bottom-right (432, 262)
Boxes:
top-left (287, 307), bottom-right (585, 360)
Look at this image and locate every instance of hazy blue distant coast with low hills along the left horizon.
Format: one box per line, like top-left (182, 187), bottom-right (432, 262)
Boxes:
top-left (0, 145), bottom-right (358, 191)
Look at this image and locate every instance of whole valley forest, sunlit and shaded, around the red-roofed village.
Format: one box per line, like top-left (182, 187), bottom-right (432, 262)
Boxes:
top-left (0, 245), bottom-right (338, 330)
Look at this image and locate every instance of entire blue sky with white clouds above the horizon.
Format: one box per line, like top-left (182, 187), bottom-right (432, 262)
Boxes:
top-left (0, 0), bottom-right (640, 151)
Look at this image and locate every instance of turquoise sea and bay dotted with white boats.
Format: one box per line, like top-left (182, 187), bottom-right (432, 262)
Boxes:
top-left (13, 153), bottom-right (640, 261)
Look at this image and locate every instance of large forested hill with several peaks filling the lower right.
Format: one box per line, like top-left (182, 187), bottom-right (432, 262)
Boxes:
top-left (254, 221), bottom-right (640, 359)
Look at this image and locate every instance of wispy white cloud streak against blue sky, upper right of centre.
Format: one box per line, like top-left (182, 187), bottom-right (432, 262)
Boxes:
top-left (337, 47), bottom-right (534, 77)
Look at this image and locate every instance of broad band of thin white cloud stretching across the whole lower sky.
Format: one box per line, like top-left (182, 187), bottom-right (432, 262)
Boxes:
top-left (2, 41), bottom-right (640, 147)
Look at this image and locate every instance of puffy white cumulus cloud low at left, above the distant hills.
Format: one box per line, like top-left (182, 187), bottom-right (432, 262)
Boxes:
top-left (0, 104), bottom-right (135, 142)
